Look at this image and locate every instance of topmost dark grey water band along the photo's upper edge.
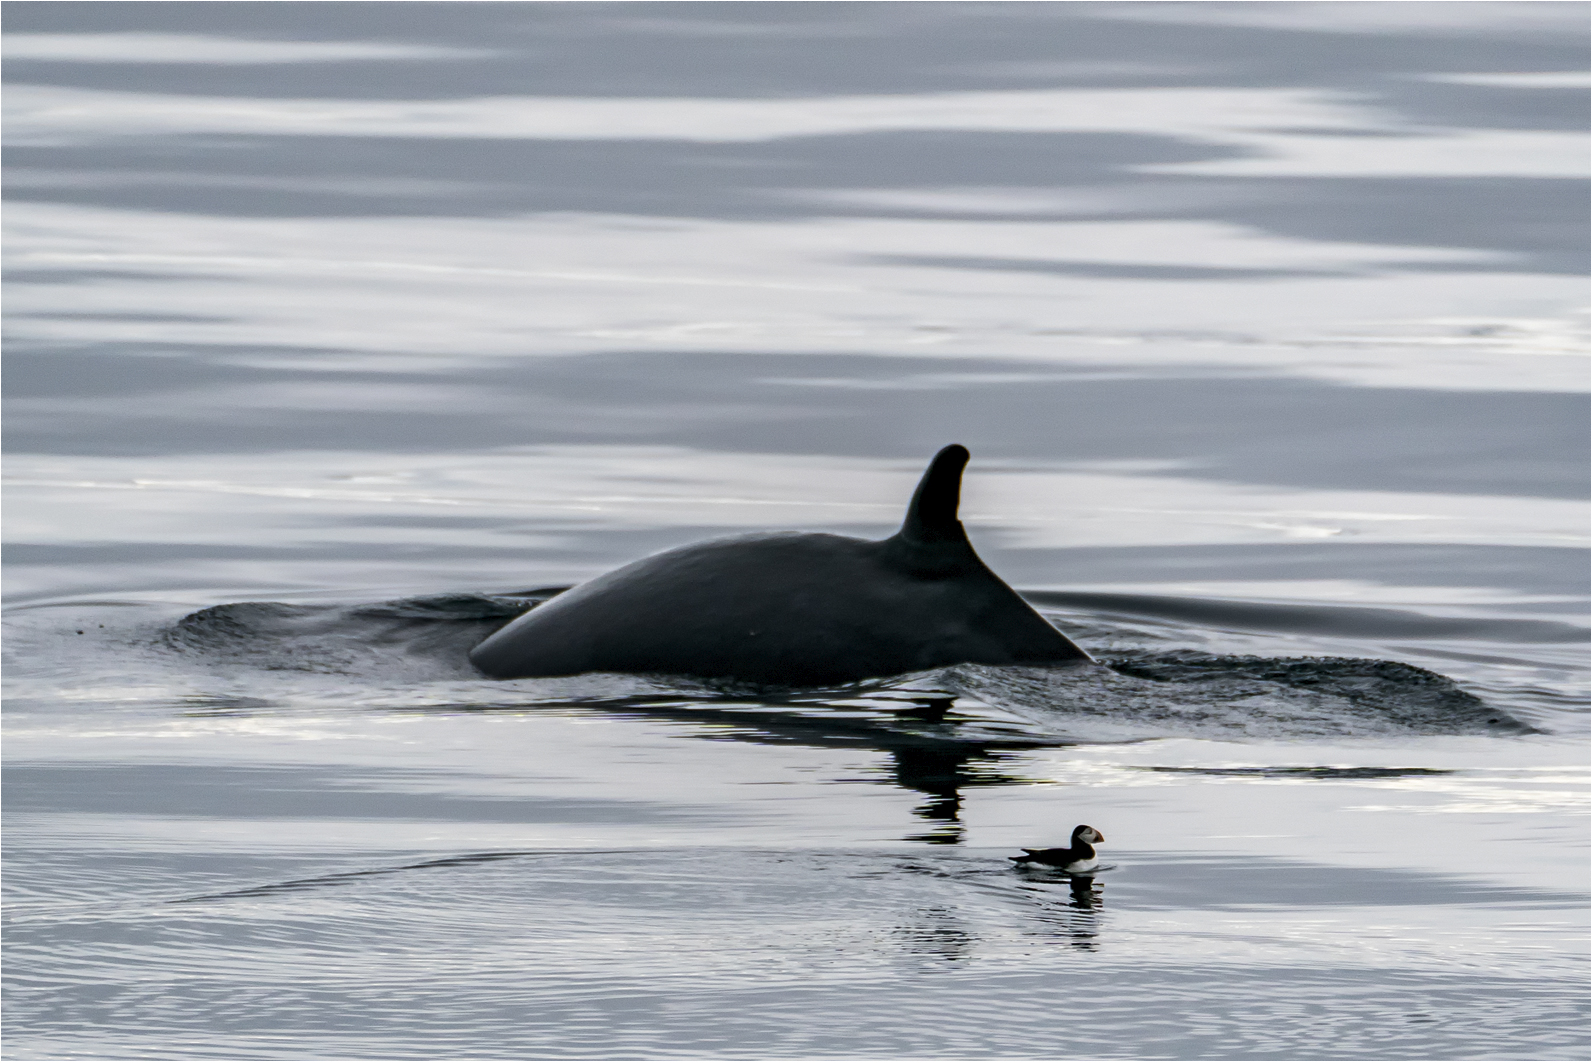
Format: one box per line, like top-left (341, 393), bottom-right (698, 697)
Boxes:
top-left (6, 2), bottom-right (1587, 105)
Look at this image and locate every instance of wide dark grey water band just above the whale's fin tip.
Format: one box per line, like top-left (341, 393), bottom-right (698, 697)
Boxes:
top-left (6, 344), bottom-right (1588, 497)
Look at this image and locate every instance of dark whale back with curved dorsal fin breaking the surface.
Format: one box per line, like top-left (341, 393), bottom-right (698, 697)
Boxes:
top-left (470, 445), bottom-right (1091, 687)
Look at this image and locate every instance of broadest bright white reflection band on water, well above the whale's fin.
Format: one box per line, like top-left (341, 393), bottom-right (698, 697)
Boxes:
top-left (6, 202), bottom-right (1587, 392)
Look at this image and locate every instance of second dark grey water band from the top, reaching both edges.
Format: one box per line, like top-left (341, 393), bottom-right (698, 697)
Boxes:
top-left (6, 131), bottom-right (1588, 272)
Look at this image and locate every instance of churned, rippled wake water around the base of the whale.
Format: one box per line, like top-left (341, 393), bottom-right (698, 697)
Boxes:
top-left (143, 586), bottom-right (1534, 747)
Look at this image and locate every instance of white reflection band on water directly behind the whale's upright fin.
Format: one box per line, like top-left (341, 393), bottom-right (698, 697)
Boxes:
top-left (8, 446), bottom-right (1585, 550)
